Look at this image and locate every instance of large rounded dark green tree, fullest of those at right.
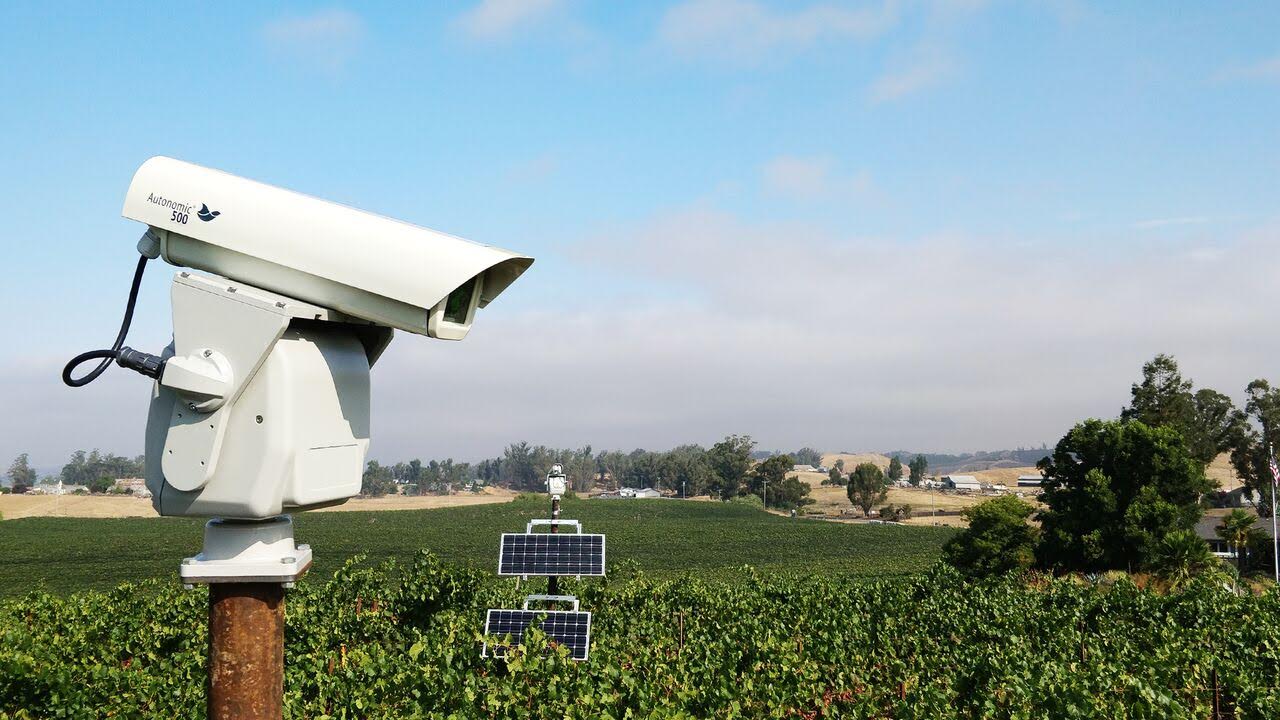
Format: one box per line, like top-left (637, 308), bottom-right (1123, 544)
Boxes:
top-left (1037, 420), bottom-right (1213, 570)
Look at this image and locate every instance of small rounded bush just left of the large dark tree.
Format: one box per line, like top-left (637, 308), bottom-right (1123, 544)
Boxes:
top-left (942, 495), bottom-right (1039, 577)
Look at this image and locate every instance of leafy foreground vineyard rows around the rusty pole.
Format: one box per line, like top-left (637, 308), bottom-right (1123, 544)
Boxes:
top-left (0, 553), bottom-right (1280, 719)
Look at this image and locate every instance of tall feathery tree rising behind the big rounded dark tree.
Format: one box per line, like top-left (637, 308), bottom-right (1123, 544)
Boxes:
top-left (1120, 354), bottom-right (1245, 465)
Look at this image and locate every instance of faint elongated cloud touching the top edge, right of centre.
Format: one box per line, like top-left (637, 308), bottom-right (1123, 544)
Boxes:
top-left (659, 0), bottom-right (899, 61)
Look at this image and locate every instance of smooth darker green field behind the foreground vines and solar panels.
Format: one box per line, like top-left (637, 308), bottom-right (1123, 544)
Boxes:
top-left (0, 488), bottom-right (955, 597)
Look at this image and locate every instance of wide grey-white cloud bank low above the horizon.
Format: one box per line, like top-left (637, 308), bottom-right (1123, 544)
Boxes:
top-left (12, 210), bottom-right (1280, 466)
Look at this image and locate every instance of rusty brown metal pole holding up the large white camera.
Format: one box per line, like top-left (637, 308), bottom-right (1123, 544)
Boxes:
top-left (206, 583), bottom-right (284, 720)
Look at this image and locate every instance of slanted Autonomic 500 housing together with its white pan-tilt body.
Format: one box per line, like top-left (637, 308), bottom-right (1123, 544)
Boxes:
top-left (122, 158), bottom-right (532, 515)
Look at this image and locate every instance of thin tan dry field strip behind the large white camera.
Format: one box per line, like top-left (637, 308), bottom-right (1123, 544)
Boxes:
top-left (0, 488), bottom-right (516, 520)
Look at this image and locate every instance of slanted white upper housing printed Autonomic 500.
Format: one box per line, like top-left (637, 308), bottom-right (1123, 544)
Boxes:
top-left (123, 156), bottom-right (532, 340)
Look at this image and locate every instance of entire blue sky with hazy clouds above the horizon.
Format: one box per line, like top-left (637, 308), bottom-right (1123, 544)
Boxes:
top-left (0, 0), bottom-right (1280, 470)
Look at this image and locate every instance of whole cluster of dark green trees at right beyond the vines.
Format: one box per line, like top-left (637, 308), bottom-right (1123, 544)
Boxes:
top-left (943, 355), bottom-right (1280, 583)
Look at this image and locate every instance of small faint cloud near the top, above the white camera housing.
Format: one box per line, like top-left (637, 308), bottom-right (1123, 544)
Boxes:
top-left (262, 9), bottom-right (366, 73)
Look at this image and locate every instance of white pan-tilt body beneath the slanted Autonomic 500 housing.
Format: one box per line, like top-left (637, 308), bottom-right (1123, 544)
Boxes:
top-left (146, 273), bottom-right (392, 519)
